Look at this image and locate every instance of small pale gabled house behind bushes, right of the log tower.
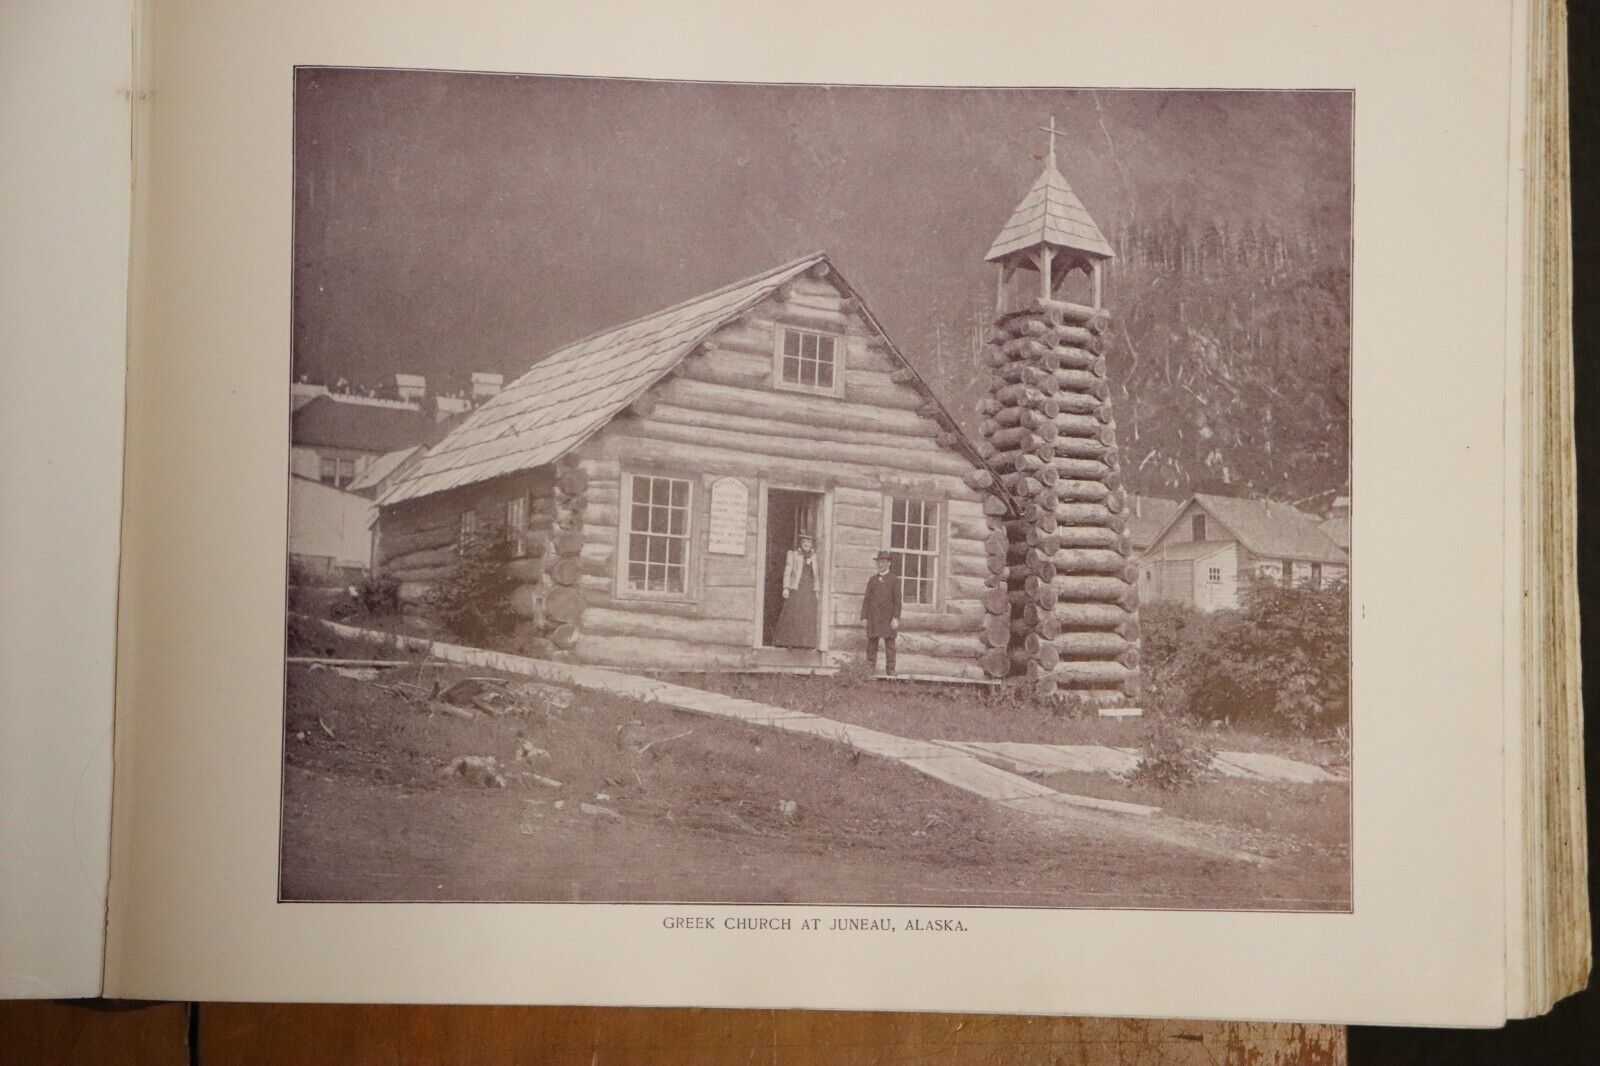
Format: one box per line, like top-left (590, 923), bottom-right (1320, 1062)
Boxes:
top-left (1139, 495), bottom-right (1350, 611)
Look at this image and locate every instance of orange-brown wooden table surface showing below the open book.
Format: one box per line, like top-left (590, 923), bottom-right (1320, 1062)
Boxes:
top-left (0, 1002), bottom-right (1346, 1066)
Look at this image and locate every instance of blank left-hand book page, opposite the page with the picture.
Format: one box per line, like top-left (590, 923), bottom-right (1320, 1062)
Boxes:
top-left (0, 0), bottom-right (133, 997)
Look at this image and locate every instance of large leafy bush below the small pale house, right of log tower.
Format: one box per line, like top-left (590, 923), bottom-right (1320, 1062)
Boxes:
top-left (1139, 579), bottom-right (1350, 731)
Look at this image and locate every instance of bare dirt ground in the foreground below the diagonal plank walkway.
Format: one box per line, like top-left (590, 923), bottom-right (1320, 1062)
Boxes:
top-left (280, 617), bottom-right (1349, 909)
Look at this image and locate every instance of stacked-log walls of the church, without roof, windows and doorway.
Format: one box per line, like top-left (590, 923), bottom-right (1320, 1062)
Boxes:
top-left (381, 265), bottom-right (990, 680)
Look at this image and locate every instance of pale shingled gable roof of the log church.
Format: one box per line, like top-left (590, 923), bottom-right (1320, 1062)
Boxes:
top-left (379, 251), bottom-right (987, 506)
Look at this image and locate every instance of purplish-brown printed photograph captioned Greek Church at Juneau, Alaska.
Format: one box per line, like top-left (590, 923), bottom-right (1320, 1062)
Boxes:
top-left (278, 67), bottom-right (1354, 909)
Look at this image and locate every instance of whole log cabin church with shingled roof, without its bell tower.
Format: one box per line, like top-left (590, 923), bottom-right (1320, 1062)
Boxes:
top-left (374, 253), bottom-right (1011, 680)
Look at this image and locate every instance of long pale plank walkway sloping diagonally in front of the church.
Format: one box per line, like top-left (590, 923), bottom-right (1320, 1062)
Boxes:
top-left (314, 619), bottom-right (1266, 864)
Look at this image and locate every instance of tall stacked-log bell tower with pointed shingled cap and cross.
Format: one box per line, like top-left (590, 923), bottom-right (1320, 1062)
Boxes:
top-left (974, 118), bottom-right (1139, 704)
